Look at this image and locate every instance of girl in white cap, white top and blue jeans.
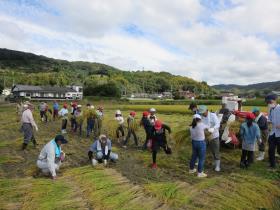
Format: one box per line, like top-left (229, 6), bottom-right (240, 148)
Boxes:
top-left (189, 114), bottom-right (209, 178)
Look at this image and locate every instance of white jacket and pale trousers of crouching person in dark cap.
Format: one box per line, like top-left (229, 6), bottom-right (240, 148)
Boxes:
top-left (37, 140), bottom-right (60, 176)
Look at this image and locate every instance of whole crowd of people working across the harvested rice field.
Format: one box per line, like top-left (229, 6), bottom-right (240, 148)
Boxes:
top-left (18, 95), bottom-right (280, 179)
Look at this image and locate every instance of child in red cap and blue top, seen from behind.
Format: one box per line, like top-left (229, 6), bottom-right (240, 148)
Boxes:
top-left (240, 113), bottom-right (261, 168)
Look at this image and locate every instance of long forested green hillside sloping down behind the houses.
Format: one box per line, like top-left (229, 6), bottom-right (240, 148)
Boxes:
top-left (0, 49), bottom-right (214, 96)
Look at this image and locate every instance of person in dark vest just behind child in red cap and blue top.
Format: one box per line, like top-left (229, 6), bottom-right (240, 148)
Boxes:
top-left (252, 107), bottom-right (268, 160)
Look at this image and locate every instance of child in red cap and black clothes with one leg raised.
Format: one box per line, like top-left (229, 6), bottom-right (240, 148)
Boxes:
top-left (151, 120), bottom-right (171, 169)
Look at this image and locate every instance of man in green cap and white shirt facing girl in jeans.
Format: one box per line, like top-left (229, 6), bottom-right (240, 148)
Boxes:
top-left (198, 105), bottom-right (221, 172)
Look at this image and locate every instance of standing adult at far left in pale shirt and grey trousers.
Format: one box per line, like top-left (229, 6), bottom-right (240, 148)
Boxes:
top-left (21, 103), bottom-right (38, 150)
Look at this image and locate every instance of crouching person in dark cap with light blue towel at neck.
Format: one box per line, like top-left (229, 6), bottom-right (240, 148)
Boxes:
top-left (37, 135), bottom-right (68, 179)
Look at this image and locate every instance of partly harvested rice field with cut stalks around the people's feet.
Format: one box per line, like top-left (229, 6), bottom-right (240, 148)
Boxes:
top-left (0, 102), bottom-right (280, 210)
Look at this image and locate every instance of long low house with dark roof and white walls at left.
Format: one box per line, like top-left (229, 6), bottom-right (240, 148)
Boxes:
top-left (12, 85), bottom-right (83, 100)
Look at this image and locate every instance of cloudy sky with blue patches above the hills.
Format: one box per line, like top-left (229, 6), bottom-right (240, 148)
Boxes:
top-left (0, 0), bottom-right (280, 85)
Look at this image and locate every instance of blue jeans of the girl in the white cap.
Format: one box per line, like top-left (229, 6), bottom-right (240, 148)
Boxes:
top-left (190, 140), bottom-right (206, 173)
